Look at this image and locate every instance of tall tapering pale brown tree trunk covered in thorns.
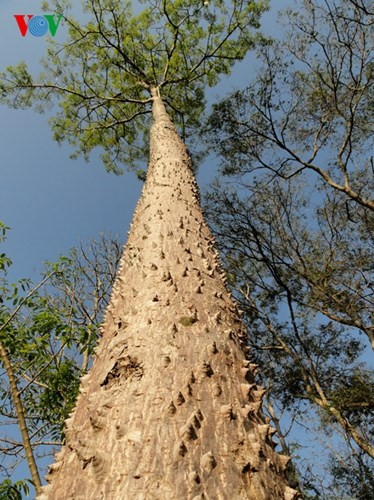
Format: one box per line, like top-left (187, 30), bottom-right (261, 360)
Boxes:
top-left (40, 90), bottom-right (296, 500)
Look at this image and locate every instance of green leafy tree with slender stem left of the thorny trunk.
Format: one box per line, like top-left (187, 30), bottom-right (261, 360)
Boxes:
top-left (0, 227), bottom-right (122, 498)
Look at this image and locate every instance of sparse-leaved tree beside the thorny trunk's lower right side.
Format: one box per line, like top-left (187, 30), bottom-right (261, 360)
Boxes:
top-left (206, 177), bottom-right (374, 497)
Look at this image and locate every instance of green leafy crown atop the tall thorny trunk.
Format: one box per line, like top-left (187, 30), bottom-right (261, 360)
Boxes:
top-left (0, 0), bottom-right (268, 173)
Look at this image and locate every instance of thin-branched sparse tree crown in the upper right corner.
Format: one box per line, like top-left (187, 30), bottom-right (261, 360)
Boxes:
top-left (206, 0), bottom-right (374, 211)
